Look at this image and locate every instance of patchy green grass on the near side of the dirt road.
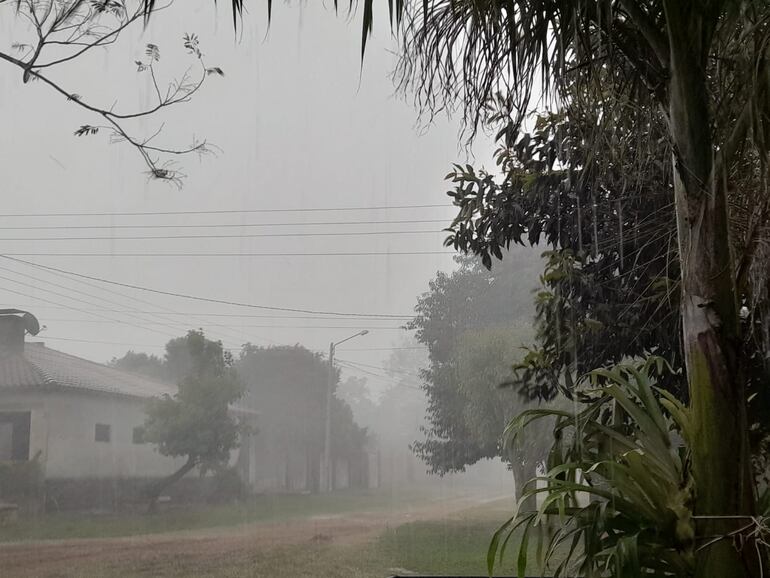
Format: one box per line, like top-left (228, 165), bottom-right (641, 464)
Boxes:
top-left (55, 508), bottom-right (540, 578)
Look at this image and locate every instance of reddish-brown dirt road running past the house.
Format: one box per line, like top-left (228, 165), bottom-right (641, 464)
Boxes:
top-left (0, 490), bottom-right (504, 578)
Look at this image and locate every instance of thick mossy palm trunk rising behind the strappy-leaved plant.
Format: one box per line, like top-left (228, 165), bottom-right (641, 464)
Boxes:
top-left (665, 0), bottom-right (758, 578)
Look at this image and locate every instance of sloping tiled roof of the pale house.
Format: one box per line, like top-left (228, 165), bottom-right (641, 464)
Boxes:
top-left (0, 343), bottom-right (176, 398)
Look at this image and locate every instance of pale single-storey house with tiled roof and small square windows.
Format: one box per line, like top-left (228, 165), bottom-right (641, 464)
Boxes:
top-left (0, 309), bottom-right (254, 507)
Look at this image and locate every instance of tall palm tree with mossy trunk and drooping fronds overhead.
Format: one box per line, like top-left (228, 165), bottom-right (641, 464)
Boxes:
top-left (145, 0), bottom-right (770, 577)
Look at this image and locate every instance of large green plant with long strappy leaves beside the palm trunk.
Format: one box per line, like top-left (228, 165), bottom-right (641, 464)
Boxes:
top-left (487, 358), bottom-right (696, 578)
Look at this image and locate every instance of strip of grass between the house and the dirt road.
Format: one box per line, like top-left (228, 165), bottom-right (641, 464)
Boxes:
top-left (0, 489), bottom-right (438, 542)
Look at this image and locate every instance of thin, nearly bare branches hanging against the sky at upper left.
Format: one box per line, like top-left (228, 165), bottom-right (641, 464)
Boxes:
top-left (0, 0), bottom-right (224, 185)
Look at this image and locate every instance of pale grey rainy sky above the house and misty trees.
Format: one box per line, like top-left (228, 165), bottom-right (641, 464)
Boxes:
top-left (0, 0), bottom-right (491, 386)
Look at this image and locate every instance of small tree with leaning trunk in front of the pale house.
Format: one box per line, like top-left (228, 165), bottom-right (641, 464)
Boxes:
top-left (144, 331), bottom-right (244, 511)
